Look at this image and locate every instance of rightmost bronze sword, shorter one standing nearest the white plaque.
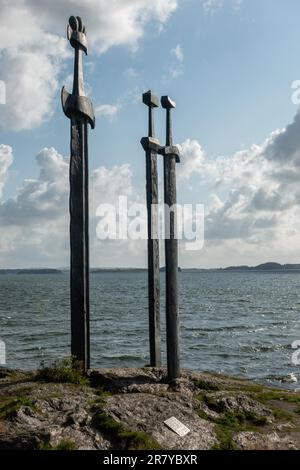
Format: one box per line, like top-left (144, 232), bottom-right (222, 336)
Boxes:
top-left (159, 96), bottom-right (180, 381)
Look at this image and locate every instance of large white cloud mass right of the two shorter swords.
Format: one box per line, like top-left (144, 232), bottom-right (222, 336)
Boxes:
top-left (179, 114), bottom-right (300, 261)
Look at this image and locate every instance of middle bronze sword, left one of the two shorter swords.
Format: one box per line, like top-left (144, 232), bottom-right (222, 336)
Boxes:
top-left (141, 91), bottom-right (161, 367)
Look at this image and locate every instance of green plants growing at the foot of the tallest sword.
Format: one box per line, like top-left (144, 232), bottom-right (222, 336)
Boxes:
top-left (36, 358), bottom-right (89, 385)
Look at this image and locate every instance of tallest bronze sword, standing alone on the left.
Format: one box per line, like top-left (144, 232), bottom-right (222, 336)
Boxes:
top-left (61, 16), bottom-right (95, 370)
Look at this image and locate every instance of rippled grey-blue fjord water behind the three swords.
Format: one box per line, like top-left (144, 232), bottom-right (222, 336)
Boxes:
top-left (0, 271), bottom-right (300, 388)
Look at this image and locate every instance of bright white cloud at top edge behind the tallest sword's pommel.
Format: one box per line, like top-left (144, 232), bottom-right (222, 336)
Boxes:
top-left (25, 0), bottom-right (177, 52)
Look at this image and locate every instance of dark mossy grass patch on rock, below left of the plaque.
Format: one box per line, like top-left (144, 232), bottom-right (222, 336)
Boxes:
top-left (92, 409), bottom-right (161, 450)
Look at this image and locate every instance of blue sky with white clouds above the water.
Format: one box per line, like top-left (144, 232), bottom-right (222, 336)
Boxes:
top-left (0, 0), bottom-right (300, 268)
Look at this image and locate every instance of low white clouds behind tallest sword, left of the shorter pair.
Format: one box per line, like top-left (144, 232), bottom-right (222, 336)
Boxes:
top-left (0, 146), bottom-right (134, 267)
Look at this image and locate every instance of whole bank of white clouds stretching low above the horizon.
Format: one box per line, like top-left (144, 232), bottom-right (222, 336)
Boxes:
top-left (0, 107), bottom-right (300, 266)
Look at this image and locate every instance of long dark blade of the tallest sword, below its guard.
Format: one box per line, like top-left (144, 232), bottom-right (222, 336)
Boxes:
top-left (70, 116), bottom-right (90, 369)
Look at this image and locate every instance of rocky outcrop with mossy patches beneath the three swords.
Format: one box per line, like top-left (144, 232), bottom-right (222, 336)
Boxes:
top-left (0, 368), bottom-right (300, 450)
